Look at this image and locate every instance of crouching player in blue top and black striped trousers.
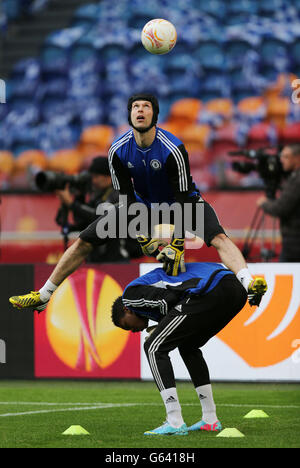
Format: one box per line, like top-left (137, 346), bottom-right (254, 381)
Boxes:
top-left (112, 263), bottom-right (247, 435)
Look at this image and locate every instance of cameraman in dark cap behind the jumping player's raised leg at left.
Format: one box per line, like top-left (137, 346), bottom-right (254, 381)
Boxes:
top-left (55, 156), bottom-right (141, 263)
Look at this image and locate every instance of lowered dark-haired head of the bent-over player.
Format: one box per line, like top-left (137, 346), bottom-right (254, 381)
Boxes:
top-left (111, 296), bottom-right (149, 333)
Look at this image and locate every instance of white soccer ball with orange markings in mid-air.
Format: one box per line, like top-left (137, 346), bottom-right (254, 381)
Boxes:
top-left (141, 19), bottom-right (177, 55)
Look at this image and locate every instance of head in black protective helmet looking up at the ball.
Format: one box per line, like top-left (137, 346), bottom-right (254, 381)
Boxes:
top-left (127, 93), bottom-right (159, 133)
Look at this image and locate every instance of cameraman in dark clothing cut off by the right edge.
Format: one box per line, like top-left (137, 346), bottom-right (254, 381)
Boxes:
top-left (257, 144), bottom-right (300, 262)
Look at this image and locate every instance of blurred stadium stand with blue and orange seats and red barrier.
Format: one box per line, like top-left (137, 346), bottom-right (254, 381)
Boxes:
top-left (0, 0), bottom-right (300, 262)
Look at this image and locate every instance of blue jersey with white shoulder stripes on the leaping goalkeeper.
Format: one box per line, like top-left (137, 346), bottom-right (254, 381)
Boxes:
top-left (108, 127), bottom-right (200, 206)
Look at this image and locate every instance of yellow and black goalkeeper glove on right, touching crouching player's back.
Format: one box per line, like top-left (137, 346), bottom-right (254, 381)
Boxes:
top-left (156, 238), bottom-right (186, 276)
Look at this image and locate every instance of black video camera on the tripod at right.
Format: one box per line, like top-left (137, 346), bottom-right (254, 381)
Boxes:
top-left (228, 148), bottom-right (284, 199)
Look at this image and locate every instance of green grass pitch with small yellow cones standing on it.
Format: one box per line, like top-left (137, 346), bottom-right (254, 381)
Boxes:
top-left (0, 381), bottom-right (300, 449)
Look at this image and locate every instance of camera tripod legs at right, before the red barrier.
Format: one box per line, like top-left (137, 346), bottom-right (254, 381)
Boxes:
top-left (242, 207), bottom-right (277, 262)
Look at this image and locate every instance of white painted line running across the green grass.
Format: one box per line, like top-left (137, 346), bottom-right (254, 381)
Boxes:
top-left (0, 401), bottom-right (300, 418)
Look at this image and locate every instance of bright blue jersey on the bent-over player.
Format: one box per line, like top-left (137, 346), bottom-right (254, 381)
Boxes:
top-left (122, 262), bottom-right (233, 321)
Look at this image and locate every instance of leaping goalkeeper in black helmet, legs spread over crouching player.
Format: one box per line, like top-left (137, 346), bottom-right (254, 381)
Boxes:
top-left (10, 94), bottom-right (267, 311)
